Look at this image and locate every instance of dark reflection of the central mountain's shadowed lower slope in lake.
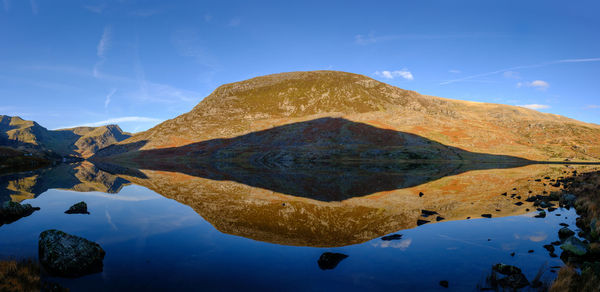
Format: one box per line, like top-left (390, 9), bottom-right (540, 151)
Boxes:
top-left (106, 160), bottom-right (525, 202)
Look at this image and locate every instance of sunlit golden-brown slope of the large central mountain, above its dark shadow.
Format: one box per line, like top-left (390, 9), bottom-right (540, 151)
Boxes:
top-left (101, 71), bottom-right (600, 161)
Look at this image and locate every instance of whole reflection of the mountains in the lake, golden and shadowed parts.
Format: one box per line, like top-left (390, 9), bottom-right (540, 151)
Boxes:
top-left (0, 162), bottom-right (584, 247)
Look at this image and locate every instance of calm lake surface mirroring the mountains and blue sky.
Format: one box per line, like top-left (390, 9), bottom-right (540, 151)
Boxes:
top-left (0, 162), bottom-right (591, 291)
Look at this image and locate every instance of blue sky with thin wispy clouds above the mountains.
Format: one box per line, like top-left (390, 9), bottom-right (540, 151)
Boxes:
top-left (0, 0), bottom-right (600, 131)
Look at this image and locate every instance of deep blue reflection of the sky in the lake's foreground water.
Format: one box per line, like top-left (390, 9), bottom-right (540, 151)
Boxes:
top-left (0, 185), bottom-right (575, 291)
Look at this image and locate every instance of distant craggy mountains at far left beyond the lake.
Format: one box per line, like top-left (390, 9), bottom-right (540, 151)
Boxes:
top-left (0, 115), bottom-right (131, 158)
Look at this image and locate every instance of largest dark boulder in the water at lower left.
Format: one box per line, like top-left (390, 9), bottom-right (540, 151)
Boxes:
top-left (38, 229), bottom-right (106, 277)
